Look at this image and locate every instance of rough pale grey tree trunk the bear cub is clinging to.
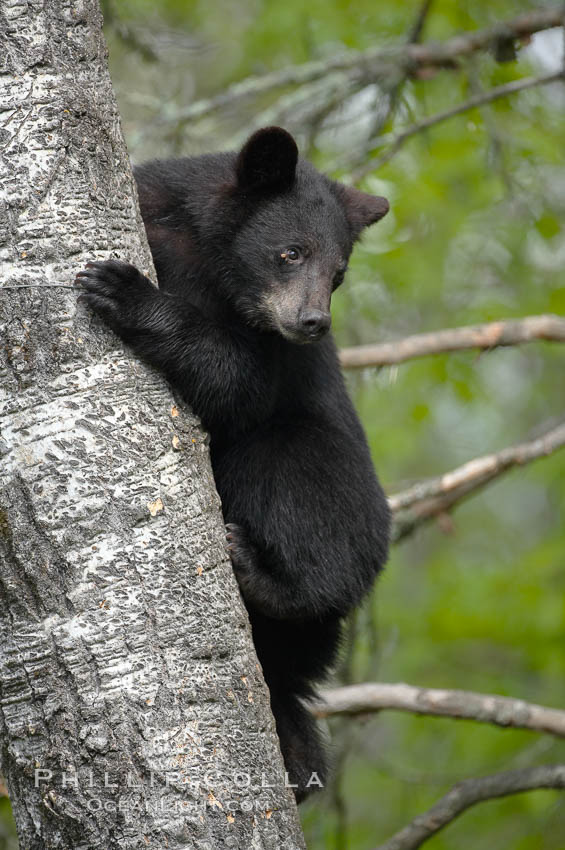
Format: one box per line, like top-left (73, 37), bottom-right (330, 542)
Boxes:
top-left (0, 0), bottom-right (304, 850)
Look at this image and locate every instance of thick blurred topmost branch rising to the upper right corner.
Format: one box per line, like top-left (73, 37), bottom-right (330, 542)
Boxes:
top-left (171, 7), bottom-right (562, 122)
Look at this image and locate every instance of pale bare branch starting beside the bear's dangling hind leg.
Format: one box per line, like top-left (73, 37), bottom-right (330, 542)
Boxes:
top-left (313, 682), bottom-right (565, 738)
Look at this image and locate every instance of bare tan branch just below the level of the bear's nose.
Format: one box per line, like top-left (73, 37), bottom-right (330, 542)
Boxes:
top-left (340, 313), bottom-right (565, 369)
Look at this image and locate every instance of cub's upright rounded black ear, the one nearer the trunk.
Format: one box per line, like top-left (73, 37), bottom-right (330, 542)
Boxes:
top-left (236, 127), bottom-right (298, 192)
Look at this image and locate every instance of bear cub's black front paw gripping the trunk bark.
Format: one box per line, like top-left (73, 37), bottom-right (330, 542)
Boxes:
top-left (75, 260), bottom-right (156, 335)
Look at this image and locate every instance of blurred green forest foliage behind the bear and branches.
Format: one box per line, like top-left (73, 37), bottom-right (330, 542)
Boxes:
top-left (0, 0), bottom-right (565, 850)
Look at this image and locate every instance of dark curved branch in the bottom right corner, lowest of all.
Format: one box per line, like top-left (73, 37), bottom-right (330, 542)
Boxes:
top-left (376, 764), bottom-right (565, 850)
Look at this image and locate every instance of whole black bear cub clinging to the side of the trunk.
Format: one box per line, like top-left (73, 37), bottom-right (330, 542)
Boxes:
top-left (77, 127), bottom-right (390, 800)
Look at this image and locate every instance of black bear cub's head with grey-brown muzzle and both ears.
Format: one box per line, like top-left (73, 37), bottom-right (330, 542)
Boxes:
top-left (214, 127), bottom-right (389, 343)
